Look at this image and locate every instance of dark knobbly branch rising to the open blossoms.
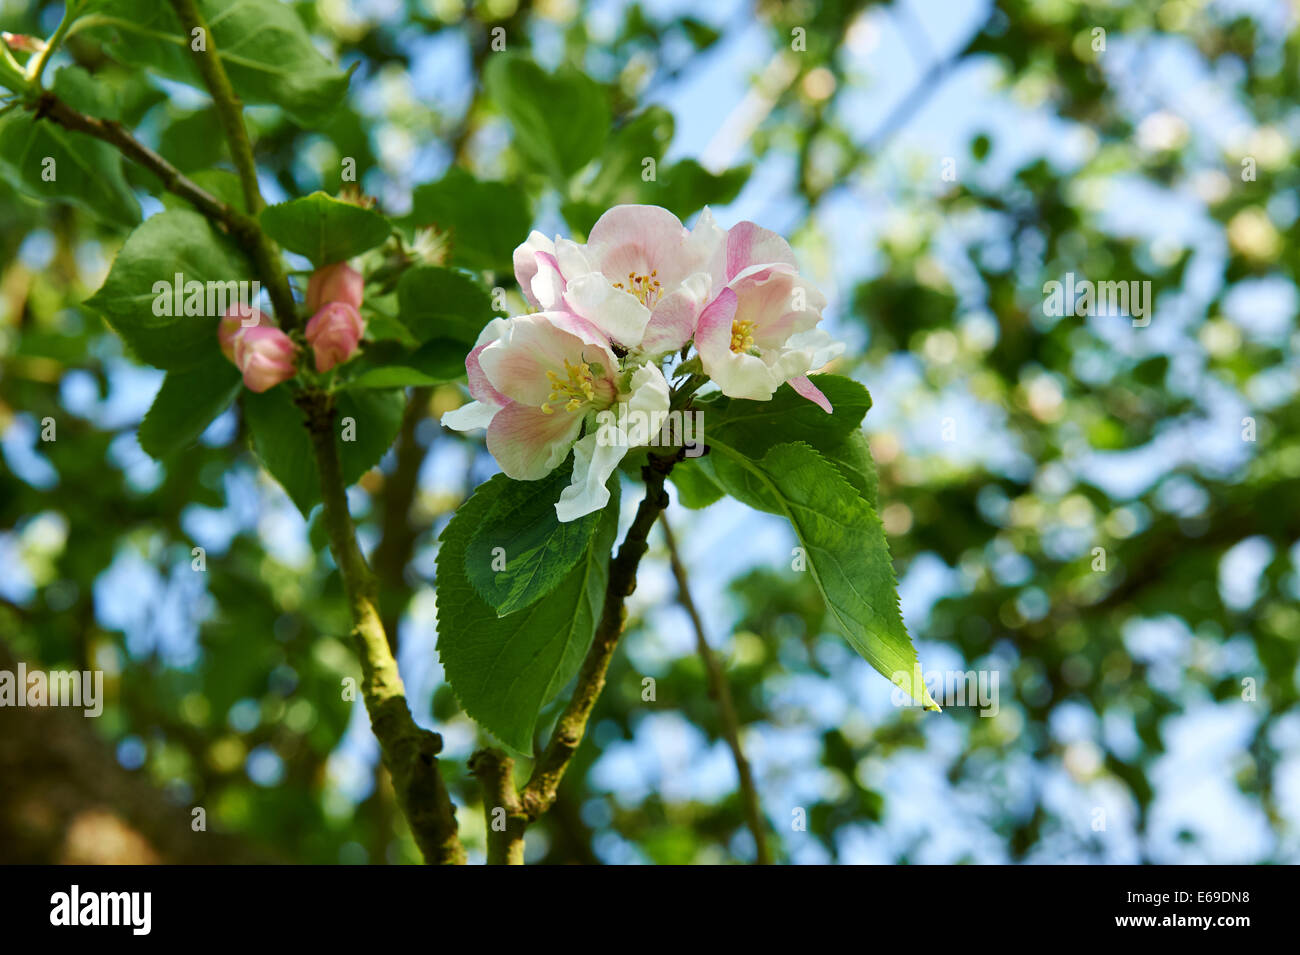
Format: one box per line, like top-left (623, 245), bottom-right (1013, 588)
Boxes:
top-left (519, 455), bottom-right (676, 821)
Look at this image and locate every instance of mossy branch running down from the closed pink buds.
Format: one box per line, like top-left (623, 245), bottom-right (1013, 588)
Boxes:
top-left (298, 391), bottom-right (465, 864)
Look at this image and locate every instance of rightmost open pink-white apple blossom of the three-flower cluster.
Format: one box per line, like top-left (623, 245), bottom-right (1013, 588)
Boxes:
top-left (696, 222), bottom-right (844, 413)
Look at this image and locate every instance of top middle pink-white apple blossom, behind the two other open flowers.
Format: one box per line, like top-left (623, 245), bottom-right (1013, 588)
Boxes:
top-left (515, 205), bottom-right (724, 355)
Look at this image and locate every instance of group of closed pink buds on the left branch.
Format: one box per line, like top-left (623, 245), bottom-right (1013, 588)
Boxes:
top-left (217, 262), bottom-right (365, 392)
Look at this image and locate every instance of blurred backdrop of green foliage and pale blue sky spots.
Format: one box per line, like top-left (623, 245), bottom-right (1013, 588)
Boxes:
top-left (0, 0), bottom-right (1300, 863)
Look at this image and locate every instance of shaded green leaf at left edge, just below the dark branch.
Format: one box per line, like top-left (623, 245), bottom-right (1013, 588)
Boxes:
top-left (0, 110), bottom-right (140, 226)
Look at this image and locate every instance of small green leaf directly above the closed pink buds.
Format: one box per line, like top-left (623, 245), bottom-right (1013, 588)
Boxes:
top-left (259, 192), bottom-right (393, 268)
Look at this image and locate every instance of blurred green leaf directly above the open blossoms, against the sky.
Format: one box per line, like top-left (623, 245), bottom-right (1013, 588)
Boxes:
top-left (484, 55), bottom-right (610, 186)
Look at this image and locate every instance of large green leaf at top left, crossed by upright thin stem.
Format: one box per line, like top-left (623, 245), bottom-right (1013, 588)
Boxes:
top-left (81, 0), bottom-right (348, 127)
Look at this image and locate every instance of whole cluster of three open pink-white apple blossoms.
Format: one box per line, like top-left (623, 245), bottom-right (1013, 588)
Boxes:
top-left (442, 205), bottom-right (844, 521)
